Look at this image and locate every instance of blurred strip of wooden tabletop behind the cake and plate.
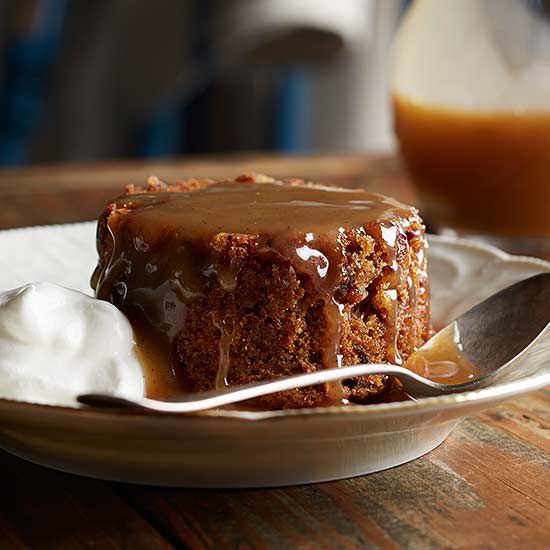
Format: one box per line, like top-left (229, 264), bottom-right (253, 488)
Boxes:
top-left (0, 155), bottom-right (414, 229)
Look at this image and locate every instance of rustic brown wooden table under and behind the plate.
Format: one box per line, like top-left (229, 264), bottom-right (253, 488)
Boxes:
top-left (0, 155), bottom-right (550, 549)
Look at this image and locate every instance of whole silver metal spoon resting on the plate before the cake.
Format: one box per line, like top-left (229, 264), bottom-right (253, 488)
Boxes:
top-left (77, 273), bottom-right (550, 413)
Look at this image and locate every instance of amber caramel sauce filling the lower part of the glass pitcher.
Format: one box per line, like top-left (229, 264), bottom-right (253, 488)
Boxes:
top-left (393, 96), bottom-right (550, 237)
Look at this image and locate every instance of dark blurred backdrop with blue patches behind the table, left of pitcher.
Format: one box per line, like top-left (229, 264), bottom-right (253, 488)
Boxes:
top-left (0, 0), bottom-right (406, 166)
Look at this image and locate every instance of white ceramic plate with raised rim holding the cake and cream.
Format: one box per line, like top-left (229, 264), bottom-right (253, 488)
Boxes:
top-left (0, 223), bottom-right (550, 487)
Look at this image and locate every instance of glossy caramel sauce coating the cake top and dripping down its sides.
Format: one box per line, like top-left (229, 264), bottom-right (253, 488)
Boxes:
top-left (92, 180), bottom-right (436, 404)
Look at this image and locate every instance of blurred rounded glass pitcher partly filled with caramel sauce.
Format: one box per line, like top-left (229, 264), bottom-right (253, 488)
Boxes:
top-left (391, 0), bottom-right (550, 257)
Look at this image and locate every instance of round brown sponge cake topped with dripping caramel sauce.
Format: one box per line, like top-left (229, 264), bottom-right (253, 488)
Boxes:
top-left (92, 175), bottom-right (430, 409)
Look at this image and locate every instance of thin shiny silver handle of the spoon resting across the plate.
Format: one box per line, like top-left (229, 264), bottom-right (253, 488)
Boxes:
top-left (77, 364), bottom-right (464, 413)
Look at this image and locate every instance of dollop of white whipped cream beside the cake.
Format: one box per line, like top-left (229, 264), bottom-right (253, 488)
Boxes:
top-left (0, 283), bottom-right (145, 406)
